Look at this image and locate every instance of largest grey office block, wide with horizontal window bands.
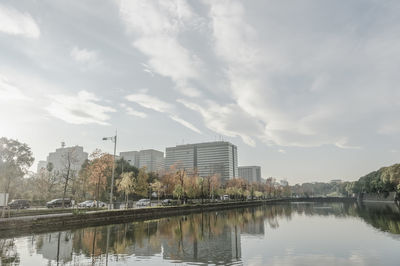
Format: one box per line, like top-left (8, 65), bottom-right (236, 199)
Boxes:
top-left (165, 141), bottom-right (238, 182)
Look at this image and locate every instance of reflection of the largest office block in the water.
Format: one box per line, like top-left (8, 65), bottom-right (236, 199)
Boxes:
top-left (160, 213), bottom-right (241, 264)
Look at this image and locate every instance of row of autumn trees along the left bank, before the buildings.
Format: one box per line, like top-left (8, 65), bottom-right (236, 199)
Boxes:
top-left (0, 138), bottom-right (290, 209)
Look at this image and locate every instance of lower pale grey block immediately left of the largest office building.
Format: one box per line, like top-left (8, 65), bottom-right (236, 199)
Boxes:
top-left (119, 149), bottom-right (164, 172)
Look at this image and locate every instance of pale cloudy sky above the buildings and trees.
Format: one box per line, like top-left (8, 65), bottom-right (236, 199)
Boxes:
top-left (0, 0), bottom-right (400, 184)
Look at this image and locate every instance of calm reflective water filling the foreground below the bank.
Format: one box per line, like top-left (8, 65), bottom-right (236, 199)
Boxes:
top-left (0, 203), bottom-right (400, 266)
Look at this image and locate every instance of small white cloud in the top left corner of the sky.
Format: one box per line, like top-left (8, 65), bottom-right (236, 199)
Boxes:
top-left (0, 4), bottom-right (40, 39)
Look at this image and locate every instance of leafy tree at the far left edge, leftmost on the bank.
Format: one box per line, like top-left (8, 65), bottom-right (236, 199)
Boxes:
top-left (0, 137), bottom-right (34, 217)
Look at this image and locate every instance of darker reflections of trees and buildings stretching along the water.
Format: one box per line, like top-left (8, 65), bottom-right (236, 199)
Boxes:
top-left (0, 203), bottom-right (400, 265)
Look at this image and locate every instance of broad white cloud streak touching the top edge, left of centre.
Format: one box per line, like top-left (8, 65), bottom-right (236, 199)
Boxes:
top-left (115, 0), bottom-right (202, 97)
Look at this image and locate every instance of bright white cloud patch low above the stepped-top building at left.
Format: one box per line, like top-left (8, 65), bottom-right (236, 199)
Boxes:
top-left (46, 91), bottom-right (116, 125)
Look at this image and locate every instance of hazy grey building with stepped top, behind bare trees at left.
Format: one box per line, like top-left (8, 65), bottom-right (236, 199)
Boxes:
top-left (38, 142), bottom-right (88, 174)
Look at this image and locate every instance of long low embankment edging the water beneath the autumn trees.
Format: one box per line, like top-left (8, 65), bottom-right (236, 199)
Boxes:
top-left (0, 198), bottom-right (356, 237)
